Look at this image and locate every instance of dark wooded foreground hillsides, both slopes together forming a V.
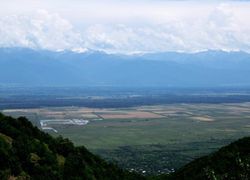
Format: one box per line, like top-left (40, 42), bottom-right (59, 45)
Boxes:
top-left (0, 114), bottom-right (250, 180)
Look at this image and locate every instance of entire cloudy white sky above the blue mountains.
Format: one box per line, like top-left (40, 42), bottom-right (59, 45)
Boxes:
top-left (0, 0), bottom-right (250, 54)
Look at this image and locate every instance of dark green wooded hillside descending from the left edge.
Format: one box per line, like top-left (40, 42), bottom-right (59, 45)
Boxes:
top-left (0, 114), bottom-right (144, 180)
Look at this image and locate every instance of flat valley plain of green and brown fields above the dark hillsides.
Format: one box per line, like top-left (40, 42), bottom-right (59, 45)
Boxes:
top-left (3, 103), bottom-right (250, 174)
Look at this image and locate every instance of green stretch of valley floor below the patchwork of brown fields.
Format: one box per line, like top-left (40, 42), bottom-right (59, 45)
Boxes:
top-left (55, 111), bottom-right (250, 174)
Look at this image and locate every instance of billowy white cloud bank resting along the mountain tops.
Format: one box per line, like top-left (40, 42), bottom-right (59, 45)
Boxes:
top-left (0, 1), bottom-right (250, 54)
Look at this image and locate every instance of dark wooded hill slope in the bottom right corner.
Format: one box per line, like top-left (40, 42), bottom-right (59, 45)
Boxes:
top-left (160, 137), bottom-right (250, 180)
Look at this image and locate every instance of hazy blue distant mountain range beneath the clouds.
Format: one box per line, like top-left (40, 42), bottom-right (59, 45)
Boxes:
top-left (0, 48), bottom-right (250, 87)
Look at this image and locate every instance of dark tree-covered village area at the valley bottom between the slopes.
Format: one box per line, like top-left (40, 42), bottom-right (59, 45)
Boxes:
top-left (95, 140), bottom-right (231, 175)
